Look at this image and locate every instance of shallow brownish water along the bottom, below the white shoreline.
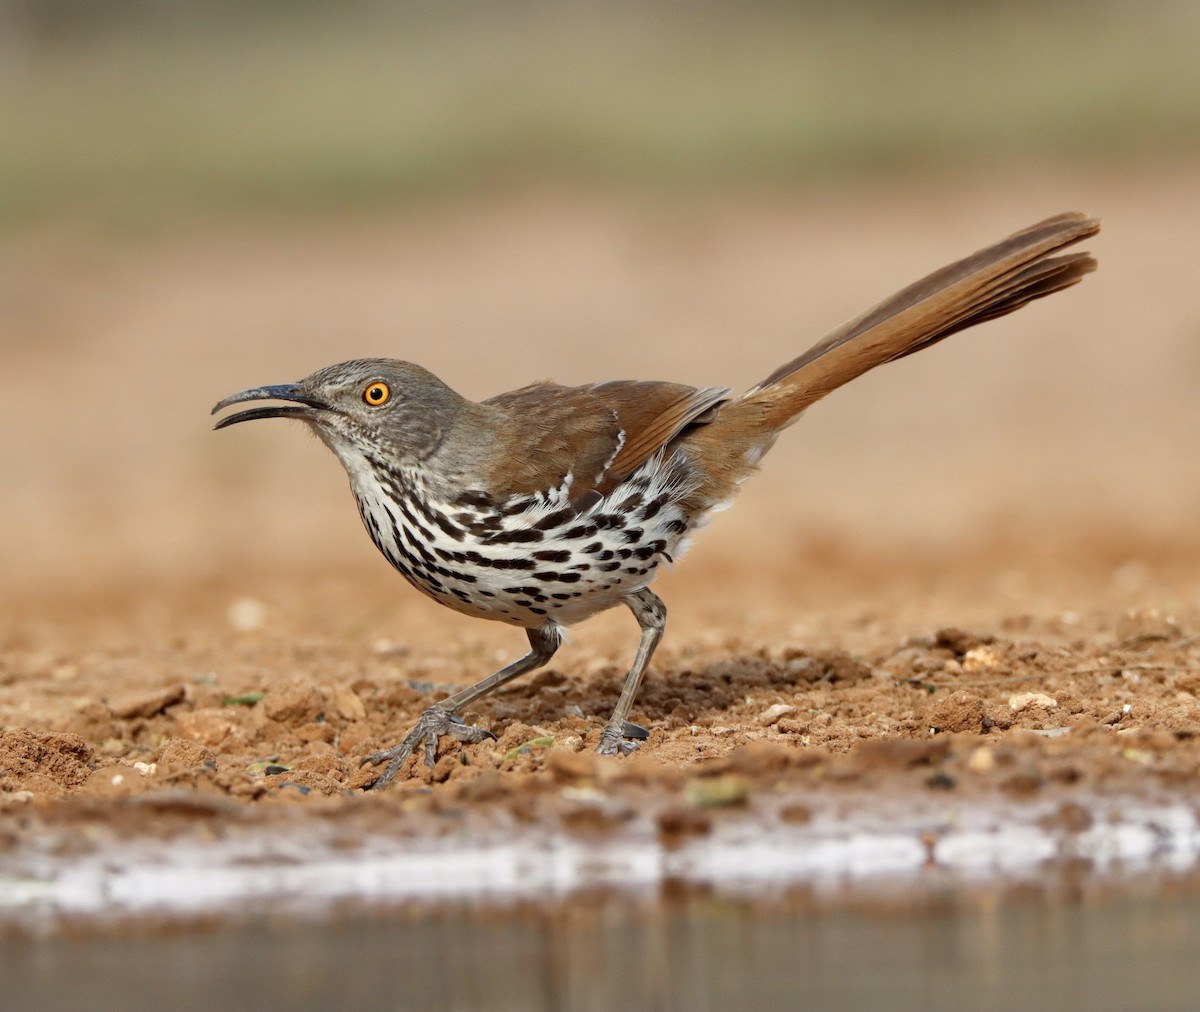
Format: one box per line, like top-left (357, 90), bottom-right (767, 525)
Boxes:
top-left (0, 891), bottom-right (1200, 1011)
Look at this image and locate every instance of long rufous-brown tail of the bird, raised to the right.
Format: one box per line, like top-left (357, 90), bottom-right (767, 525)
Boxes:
top-left (722, 212), bottom-right (1100, 435)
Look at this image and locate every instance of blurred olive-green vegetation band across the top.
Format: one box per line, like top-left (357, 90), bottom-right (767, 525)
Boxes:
top-left (0, 0), bottom-right (1200, 221)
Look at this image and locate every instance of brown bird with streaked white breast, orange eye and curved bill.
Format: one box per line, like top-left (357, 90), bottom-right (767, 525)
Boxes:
top-left (212, 212), bottom-right (1099, 789)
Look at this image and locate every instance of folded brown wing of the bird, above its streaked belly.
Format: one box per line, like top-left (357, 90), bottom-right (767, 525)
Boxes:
top-left (484, 379), bottom-right (731, 507)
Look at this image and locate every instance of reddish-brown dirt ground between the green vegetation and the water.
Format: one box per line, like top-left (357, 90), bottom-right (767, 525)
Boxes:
top-left (0, 169), bottom-right (1200, 926)
